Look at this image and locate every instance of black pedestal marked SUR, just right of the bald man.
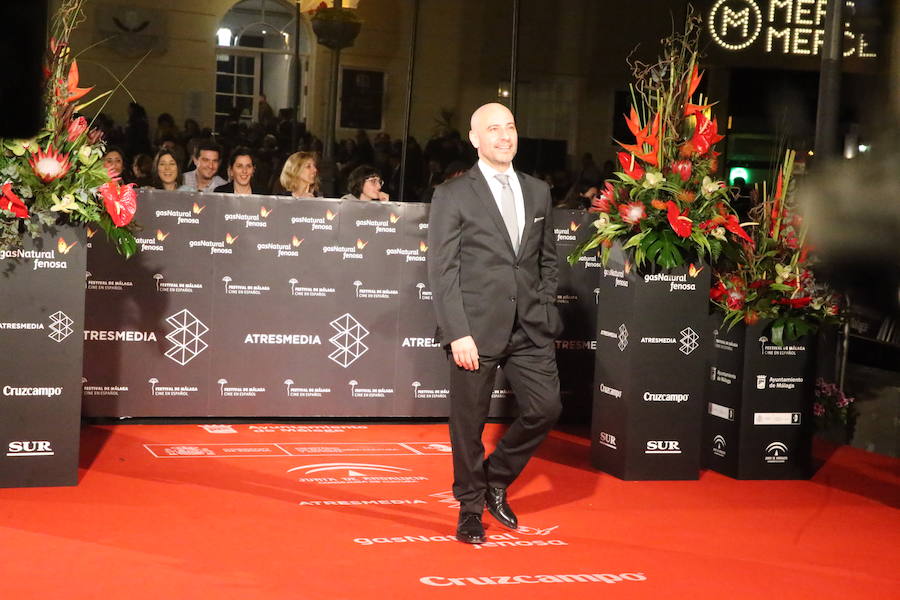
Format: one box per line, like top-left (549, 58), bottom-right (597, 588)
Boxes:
top-left (591, 241), bottom-right (709, 480)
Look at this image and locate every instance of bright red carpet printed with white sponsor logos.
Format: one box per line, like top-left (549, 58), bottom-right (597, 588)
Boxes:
top-left (0, 424), bottom-right (900, 600)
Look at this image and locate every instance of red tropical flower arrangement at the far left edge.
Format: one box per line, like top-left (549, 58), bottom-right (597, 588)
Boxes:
top-left (0, 0), bottom-right (137, 258)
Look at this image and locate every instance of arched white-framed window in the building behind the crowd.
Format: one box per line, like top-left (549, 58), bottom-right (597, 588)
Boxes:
top-left (214, 0), bottom-right (310, 132)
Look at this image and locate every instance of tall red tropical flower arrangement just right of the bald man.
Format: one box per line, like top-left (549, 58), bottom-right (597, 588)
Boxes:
top-left (569, 14), bottom-right (750, 268)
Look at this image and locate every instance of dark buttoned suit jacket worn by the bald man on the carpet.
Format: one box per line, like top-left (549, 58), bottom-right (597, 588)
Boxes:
top-left (428, 165), bottom-right (562, 355)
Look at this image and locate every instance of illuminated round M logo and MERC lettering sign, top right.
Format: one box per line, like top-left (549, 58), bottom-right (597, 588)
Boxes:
top-left (706, 0), bottom-right (876, 58)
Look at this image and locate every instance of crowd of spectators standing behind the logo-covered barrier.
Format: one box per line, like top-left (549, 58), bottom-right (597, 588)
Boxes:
top-left (95, 99), bottom-right (612, 208)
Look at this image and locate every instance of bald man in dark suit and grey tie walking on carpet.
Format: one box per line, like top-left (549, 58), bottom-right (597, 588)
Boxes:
top-left (428, 103), bottom-right (562, 544)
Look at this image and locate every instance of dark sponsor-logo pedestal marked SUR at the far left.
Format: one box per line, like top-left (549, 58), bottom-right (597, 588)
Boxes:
top-left (0, 227), bottom-right (86, 487)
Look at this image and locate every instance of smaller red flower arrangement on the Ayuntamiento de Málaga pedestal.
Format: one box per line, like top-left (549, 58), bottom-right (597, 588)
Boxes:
top-left (710, 150), bottom-right (840, 346)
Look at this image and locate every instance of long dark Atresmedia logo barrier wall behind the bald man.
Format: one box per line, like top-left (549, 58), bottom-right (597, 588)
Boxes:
top-left (83, 190), bottom-right (600, 417)
